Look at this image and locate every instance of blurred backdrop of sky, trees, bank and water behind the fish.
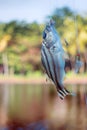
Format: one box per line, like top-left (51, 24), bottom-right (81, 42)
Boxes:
top-left (0, 0), bottom-right (87, 130)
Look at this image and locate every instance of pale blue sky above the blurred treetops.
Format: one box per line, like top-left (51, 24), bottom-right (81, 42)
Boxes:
top-left (0, 0), bottom-right (87, 23)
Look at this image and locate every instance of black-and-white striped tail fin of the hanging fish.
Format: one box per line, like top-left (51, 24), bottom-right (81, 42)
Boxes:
top-left (57, 88), bottom-right (76, 100)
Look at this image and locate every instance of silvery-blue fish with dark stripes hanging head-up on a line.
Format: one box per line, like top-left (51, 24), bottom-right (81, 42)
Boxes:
top-left (41, 19), bottom-right (74, 99)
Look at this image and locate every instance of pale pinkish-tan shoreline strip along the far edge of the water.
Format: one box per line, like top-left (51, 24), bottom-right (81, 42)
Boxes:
top-left (0, 75), bottom-right (87, 85)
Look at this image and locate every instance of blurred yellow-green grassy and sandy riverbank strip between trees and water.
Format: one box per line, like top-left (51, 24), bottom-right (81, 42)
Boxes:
top-left (0, 73), bottom-right (87, 85)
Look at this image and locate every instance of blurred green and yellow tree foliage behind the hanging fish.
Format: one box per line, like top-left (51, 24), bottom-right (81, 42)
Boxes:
top-left (0, 7), bottom-right (87, 75)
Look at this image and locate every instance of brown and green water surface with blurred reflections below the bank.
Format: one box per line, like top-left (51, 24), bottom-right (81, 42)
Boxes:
top-left (0, 85), bottom-right (87, 130)
